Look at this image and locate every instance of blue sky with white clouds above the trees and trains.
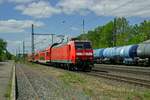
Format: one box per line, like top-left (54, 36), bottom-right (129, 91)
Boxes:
top-left (0, 0), bottom-right (150, 53)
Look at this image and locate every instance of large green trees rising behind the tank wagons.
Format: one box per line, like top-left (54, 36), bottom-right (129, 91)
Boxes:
top-left (78, 18), bottom-right (150, 48)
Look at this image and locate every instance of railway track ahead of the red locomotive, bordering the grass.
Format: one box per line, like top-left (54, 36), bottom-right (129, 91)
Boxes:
top-left (86, 71), bottom-right (150, 88)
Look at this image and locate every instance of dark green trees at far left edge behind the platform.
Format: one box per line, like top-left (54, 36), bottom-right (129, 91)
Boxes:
top-left (0, 39), bottom-right (12, 61)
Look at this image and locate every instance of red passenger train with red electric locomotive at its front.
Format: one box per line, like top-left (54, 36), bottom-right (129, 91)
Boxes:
top-left (28, 40), bottom-right (94, 71)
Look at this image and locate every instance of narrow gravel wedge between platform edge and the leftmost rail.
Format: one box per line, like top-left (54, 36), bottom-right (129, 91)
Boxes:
top-left (16, 65), bottom-right (40, 100)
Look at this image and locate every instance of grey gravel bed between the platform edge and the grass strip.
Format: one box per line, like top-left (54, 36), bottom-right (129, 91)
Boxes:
top-left (16, 64), bottom-right (89, 100)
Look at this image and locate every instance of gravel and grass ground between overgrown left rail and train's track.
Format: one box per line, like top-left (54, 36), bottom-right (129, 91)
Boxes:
top-left (15, 63), bottom-right (150, 100)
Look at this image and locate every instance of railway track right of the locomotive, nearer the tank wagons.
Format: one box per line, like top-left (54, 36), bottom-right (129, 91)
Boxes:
top-left (93, 64), bottom-right (150, 76)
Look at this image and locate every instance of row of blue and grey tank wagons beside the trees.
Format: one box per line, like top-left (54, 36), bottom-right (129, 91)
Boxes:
top-left (94, 43), bottom-right (150, 66)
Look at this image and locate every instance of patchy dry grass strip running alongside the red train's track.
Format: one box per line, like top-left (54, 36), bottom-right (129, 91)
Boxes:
top-left (25, 64), bottom-right (150, 100)
